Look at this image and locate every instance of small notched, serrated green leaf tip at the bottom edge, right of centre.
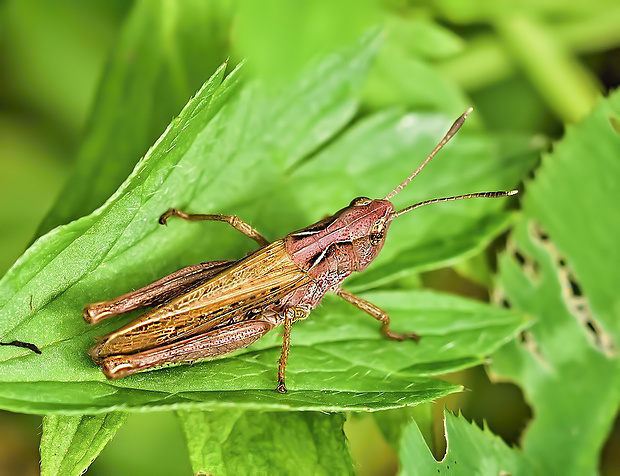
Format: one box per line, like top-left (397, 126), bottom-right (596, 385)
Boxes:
top-left (399, 412), bottom-right (536, 476)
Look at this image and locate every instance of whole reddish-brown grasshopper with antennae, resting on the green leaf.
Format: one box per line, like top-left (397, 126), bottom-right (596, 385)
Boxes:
top-left (84, 108), bottom-right (517, 393)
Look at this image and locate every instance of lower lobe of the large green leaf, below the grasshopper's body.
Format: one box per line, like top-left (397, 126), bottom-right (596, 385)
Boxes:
top-left (0, 291), bottom-right (525, 413)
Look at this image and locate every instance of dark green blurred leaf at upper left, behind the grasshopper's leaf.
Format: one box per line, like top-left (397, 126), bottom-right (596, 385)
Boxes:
top-left (37, 0), bottom-right (231, 235)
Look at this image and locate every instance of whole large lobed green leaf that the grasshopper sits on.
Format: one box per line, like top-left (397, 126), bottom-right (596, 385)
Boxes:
top-left (0, 35), bottom-right (525, 413)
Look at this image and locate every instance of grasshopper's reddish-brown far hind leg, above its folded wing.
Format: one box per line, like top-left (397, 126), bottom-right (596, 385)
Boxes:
top-left (83, 261), bottom-right (233, 324)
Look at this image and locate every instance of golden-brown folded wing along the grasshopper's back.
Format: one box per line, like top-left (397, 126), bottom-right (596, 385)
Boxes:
top-left (90, 240), bottom-right (310, 363)
